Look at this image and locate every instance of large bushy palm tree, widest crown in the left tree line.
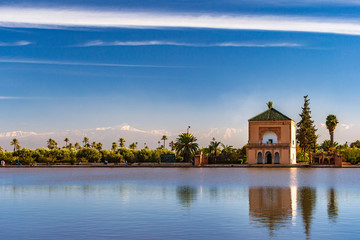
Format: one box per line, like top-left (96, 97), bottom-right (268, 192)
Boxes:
top-left (175, 133), bottom-right (199, 162)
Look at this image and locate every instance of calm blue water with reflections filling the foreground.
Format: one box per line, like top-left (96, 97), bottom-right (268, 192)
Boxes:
top-left (0, 168), bottom-right (360, 239)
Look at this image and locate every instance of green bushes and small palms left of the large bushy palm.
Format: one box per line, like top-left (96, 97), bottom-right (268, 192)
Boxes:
top-left (0, 137), bottom-right (176, 164)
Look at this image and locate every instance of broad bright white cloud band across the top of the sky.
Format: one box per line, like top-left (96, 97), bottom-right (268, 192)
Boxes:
top-left (0, 7), bottom-right (360, 35)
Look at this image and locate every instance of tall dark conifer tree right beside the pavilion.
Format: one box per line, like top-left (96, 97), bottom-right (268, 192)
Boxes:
top-left (296, 95), bottom-right (317, 159)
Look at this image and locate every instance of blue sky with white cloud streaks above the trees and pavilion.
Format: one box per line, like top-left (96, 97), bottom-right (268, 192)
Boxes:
top-left (0, 0), bottom-right (360, 150)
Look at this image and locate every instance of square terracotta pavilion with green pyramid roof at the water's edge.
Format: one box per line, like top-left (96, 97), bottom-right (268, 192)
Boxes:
top-left (247, 104), bottom-right (296, 164)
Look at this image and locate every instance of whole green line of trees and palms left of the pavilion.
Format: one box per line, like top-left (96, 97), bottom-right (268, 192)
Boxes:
top-left (0, 132), bottom-right (246, 164)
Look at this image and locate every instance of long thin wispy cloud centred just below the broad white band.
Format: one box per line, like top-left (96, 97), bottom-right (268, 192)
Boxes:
top-left (76, 40), bottom-right (303, 48)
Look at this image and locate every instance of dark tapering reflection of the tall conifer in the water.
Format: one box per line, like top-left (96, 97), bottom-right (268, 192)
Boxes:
top-left (299, 187), bottom-right (316, 238)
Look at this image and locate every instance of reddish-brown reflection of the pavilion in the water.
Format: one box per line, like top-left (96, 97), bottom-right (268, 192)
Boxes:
top-left (249, 187), bottom-right (292, 236)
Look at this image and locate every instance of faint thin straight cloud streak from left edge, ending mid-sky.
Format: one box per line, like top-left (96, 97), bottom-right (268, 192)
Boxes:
top-left (0, 58), bottom-right (190, 68)
